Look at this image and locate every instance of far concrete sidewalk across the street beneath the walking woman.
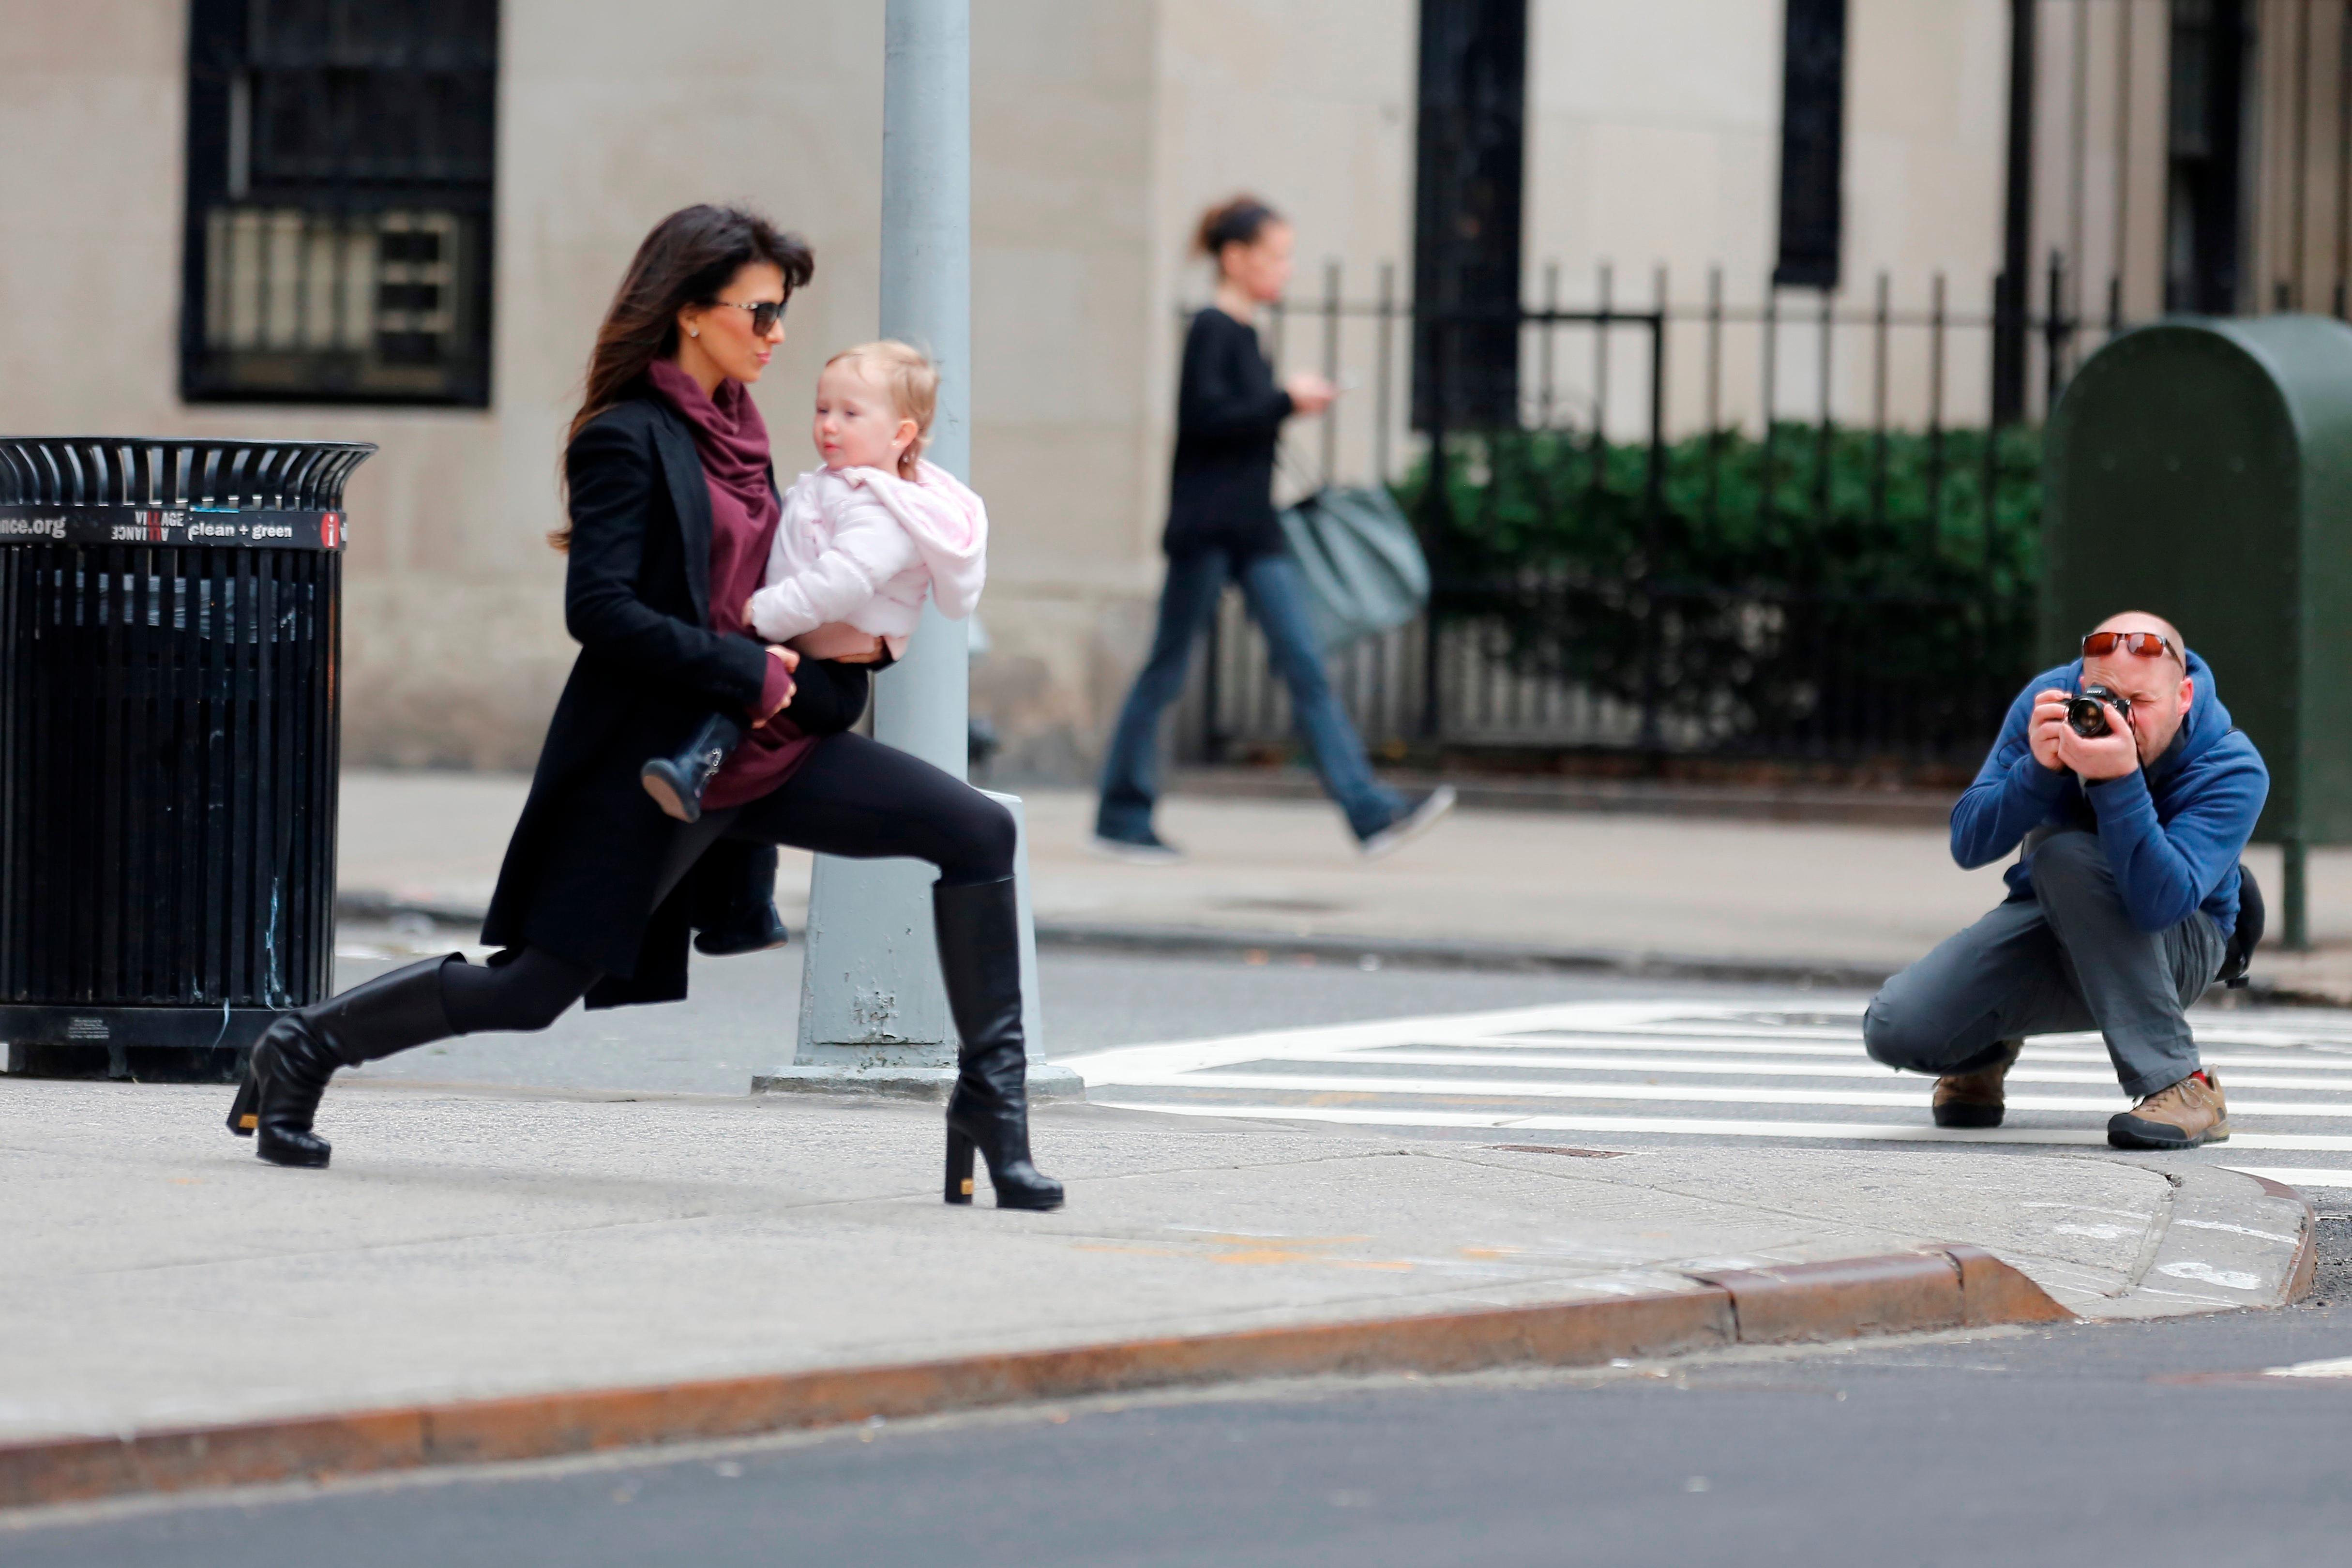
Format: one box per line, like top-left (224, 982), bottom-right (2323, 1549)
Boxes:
top-left (341, 773), bottom-right (2352, 1004)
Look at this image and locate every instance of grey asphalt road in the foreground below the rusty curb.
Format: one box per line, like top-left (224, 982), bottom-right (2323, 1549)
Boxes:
top-left (14, 1220), bottom-right (2352, 1568)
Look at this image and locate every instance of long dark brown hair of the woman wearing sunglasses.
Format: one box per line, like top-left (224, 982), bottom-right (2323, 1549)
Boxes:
top-left (548, 207), bottom-right (816, 550)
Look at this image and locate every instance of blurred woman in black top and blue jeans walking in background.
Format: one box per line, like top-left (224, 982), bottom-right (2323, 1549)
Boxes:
top-left (1094, 195), bottom-right (1453, 865)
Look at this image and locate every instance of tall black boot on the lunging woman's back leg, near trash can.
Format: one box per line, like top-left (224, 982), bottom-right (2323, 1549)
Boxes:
top-left (228, 952), bottom-right (463, 1166)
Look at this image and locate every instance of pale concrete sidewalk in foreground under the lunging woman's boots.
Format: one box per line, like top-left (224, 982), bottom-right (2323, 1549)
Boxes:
top-left (0, 1079), bottom-right (2310, 1505)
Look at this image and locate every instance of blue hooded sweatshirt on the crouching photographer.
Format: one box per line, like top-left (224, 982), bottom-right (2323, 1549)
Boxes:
top-left (1952, 653), bottom-right (2270, 938)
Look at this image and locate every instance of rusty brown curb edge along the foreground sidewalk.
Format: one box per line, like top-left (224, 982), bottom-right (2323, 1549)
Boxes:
top-left (0, 1244), bottom-right (2075, 1509)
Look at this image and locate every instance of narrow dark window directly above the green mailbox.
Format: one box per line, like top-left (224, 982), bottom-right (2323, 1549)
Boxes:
top-left (2164, 0), bottom-right (2246, 315)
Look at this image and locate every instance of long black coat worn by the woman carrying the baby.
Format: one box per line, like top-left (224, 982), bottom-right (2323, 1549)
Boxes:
top-left (482, 388), bottom-right (774, 1006)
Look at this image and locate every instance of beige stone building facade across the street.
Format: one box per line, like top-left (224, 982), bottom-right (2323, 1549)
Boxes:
top-left (0, 0), bottom-right (2343, 778)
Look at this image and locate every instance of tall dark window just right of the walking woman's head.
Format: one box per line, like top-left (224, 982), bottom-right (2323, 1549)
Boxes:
top-left (1414, 0), bottom-right (1526, 430)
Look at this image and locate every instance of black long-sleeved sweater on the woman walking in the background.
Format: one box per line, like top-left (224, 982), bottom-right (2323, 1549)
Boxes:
top-left (1162, 305), bottom-right (1291, 562)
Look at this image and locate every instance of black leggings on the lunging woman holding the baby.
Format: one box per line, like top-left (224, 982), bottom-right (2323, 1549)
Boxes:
top-left (442, 734), bottom-right (1016, 1034)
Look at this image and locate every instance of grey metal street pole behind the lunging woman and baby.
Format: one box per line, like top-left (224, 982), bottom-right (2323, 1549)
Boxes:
top-left (795, 0), bottom-right (971, 1077)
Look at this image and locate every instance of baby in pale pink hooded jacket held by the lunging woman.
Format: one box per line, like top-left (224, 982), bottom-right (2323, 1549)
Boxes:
top-left (640, 338), bottom-right (988, 823)
